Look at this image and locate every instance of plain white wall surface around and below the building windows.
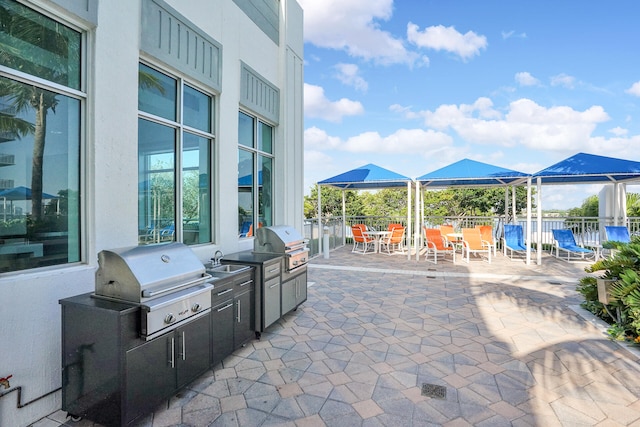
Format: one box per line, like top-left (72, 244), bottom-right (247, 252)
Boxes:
top-left (0, 0), bottom-right (303, 426)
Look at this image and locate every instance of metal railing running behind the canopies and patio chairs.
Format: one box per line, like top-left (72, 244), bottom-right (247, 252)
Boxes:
top-left (304, 216), bottom-right (640, 258)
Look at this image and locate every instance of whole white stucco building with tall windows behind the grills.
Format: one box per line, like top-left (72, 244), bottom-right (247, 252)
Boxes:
top-left (0, 0), bottom-right (303, 426)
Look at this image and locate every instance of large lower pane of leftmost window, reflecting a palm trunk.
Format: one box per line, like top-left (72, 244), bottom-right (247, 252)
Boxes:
top-left (0, 77), bottom-right (80, 272)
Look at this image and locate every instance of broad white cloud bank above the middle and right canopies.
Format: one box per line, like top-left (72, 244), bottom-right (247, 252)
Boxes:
top-left (421, 98), bottom-right (609, 151)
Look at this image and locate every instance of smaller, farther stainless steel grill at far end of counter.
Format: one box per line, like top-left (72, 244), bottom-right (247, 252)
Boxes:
top-left (253, 225), bottom-right (309, 272)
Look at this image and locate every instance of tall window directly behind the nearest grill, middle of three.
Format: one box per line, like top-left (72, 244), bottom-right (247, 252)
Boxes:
top-left (138, 64), bottom-right (214, 245)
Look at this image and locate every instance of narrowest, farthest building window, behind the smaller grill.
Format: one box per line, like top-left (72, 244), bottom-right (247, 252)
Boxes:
top-left (238, 112), bottom-right (274, 238)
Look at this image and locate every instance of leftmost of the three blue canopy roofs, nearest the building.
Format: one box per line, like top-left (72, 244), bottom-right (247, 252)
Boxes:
top-left (318, 163), bottom-right (411, 190)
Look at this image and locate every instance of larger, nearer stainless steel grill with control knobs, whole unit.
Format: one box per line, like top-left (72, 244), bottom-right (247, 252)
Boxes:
top-left (94, 242), bottom-right (213, 340)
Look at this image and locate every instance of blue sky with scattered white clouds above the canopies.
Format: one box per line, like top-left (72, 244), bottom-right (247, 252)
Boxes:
top-left (298, 0), bottom-right (640, 209)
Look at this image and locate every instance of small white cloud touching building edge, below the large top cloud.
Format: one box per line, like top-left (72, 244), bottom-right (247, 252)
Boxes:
top-left (304, 83), bottom-right (364, 123)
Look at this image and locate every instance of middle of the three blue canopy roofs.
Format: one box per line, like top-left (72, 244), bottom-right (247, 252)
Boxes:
top-left (416, 159), bottom-right (529, 187)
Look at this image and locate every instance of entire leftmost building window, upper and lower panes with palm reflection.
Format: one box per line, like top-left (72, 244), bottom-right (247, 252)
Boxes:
top-left (0, 0), bottom-right (86, 272)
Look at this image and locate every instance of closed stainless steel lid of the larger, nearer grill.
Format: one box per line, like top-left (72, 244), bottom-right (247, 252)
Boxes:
top-left (95, 242), bottom-right (209, 303)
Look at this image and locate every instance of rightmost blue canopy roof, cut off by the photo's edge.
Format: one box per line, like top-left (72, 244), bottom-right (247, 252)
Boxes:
top-left (533, 153), bottom-right (640, 184)
